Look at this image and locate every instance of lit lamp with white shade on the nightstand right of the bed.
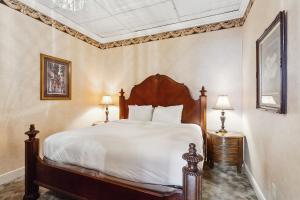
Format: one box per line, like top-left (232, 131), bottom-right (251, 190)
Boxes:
top-left (213, 95), bottom-right (233, 134)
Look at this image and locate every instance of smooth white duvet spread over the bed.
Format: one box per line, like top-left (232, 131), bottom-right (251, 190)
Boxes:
top-left (44, 120), bottom-right (203, 186)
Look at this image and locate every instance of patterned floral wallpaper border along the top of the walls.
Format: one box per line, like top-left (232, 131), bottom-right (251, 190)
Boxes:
top-left (0, 0), bottom-right (254, 49)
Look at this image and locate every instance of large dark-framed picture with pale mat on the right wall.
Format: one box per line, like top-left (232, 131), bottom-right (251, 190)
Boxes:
top-left (256, 11), bottom-right (287, 114)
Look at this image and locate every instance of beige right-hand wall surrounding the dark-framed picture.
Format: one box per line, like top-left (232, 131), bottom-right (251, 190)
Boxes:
top-left (243, 0), bottom-right (300, 200)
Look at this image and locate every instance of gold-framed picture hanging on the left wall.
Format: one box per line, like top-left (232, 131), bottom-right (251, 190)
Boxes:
top-left (41, 54), bottom-right (72, 100)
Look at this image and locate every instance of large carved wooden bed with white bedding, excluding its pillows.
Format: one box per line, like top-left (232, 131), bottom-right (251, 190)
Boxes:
top-left (24, 74), bottom-right (207, 200)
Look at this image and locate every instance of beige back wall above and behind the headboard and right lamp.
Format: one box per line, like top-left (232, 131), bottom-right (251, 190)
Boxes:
top-left (101, 28), bottom-right (242, 131)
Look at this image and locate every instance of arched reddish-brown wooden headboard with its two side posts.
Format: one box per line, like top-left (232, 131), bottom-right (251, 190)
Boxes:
top-left (119, 74), bottom-right (207, 131)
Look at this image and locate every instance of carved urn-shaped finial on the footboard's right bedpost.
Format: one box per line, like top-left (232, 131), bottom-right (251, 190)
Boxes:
top-left (182, 143), bottom-right (203, 173)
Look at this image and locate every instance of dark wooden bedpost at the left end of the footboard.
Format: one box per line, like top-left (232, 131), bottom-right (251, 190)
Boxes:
top-left (23, 124), bottom-right (40, 200)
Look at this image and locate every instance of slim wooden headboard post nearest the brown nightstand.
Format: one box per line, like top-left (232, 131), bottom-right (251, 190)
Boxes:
top-left (199, 86), bottom-right (207, 162)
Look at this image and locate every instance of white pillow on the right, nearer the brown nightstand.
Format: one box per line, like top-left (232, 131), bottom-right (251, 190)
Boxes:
top-left (152, 105), bottom-right (183, 124)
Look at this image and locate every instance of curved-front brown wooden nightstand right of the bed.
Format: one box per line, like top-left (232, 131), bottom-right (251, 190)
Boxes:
top-left (208, 131), bottom-right (244, 173)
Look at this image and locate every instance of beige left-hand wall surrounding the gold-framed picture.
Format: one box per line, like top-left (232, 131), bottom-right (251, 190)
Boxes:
top-left (0, 4), bottom-right (104, 174)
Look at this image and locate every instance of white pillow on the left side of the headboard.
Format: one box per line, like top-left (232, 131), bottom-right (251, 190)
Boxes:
top-left (128, 105), bottom-right (153, 121)
